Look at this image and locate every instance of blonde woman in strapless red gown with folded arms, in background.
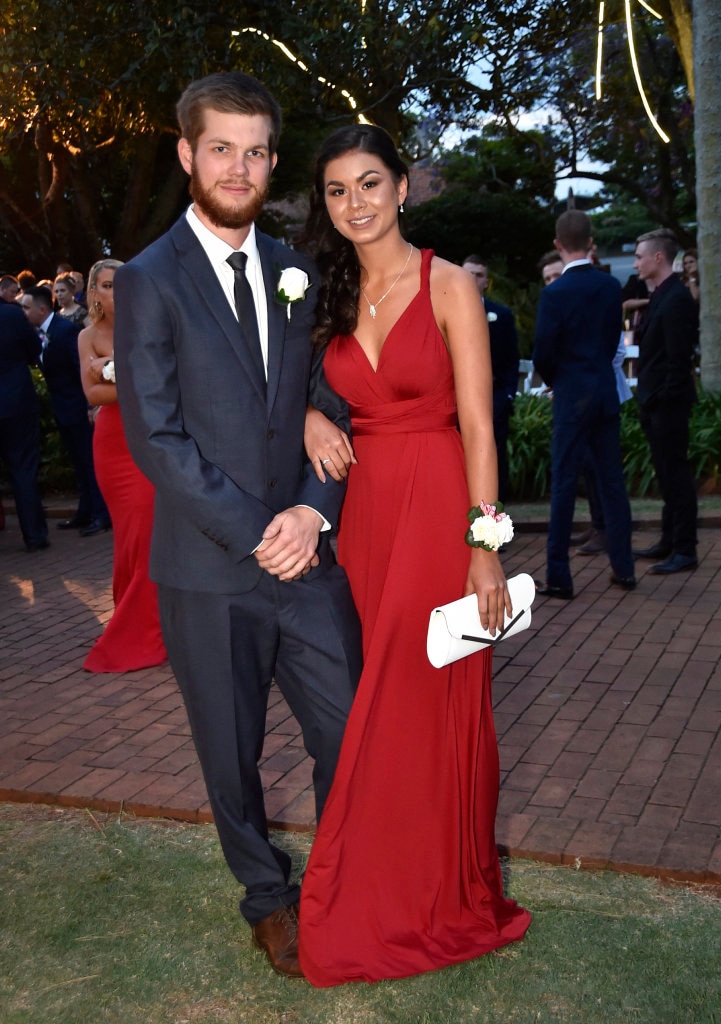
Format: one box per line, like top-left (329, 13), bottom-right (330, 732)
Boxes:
top-left (78, 259), bottom-right (168, 672)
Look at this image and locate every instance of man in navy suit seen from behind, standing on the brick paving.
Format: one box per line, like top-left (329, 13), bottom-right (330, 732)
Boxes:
top-left (534, 210), bottom-right (636, 599)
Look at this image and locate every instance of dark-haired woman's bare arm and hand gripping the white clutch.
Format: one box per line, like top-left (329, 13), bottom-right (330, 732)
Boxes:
top-left (430, 258), bottom-right (512, 632)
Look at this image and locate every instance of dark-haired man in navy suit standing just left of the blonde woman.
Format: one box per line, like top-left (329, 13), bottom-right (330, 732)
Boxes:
top-left (20, 285), bottom-right (111, 537)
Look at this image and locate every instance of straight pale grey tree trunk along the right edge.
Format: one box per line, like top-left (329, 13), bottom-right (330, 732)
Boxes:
top-left (693, 0), bottom-right (721, 391)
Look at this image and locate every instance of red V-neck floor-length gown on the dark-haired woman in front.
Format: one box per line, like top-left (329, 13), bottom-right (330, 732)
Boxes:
top-left (299, 250), bottom-right (531, 985)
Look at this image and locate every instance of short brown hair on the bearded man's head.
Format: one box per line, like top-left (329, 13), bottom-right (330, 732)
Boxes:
top-left (176, 71), bottom-right (283, 154)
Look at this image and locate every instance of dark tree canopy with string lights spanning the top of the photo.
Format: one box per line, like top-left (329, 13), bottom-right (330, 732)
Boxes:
top-left (0, 0), bottom-right (693, 273)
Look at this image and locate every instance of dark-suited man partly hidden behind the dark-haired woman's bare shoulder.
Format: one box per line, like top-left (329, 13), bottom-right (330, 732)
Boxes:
top-left (463, 253), bottom-right (519, 504)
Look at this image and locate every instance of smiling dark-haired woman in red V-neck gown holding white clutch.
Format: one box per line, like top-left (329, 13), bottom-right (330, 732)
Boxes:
top-left (299, 125), bottom-right (531, 985)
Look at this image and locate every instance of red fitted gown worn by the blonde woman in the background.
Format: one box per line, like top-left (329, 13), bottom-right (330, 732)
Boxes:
top-left (83, 402), bottom-right (168, 672)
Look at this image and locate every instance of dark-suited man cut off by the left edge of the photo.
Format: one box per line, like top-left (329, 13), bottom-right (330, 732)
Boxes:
top-left (0, 274), bottom-right (48, 551)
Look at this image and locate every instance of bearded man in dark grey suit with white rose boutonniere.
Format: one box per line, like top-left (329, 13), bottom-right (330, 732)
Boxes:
top-left (115, 72), bottom-right (361, 977)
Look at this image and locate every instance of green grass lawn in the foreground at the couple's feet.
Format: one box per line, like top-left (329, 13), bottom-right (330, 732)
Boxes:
top-left (5, 805), bottom-right (721, 1024)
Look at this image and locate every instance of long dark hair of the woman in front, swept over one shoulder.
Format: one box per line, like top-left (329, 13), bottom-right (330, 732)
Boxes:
top-left (304, 125), bottom-right (408, 348)
